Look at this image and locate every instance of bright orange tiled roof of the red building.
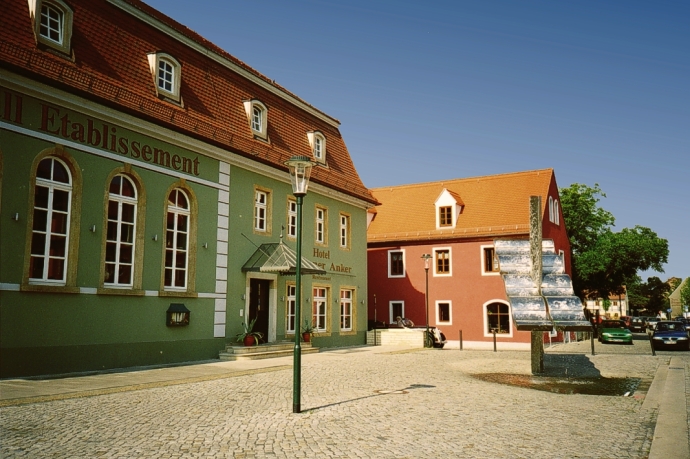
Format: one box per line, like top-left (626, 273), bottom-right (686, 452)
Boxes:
top-left (367, 169), bottom-right (554, 243)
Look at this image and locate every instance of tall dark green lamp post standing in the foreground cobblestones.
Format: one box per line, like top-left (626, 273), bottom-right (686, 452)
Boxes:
top-left (285, 156), bottom-right (314, 413)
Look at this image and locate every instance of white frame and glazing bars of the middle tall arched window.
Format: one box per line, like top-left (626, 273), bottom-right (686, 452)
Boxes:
top-left (103, 174), bottom-right (138, 288)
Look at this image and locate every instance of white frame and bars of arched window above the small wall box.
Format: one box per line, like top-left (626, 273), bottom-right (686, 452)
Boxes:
top-left (163, 188), bottom-right (192, 291)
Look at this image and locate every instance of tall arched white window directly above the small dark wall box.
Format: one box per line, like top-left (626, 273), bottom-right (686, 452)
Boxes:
top-left (165, 188), bottom-right (191, 290)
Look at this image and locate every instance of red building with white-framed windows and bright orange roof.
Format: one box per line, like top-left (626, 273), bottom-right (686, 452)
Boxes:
top-left (367, 169), bottom-right (570, 349)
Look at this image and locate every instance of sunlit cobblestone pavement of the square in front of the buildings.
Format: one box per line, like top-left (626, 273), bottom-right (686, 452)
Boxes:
top-left (0, 341), bottom-right (690, 458)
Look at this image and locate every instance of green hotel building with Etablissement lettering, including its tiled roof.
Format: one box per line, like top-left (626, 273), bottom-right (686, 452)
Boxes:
top-left (0, 0), bottom-right (376, 377)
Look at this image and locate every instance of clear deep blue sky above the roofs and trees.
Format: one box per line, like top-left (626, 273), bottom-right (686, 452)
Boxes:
top-left (142, 0), bottom-right (690, 280)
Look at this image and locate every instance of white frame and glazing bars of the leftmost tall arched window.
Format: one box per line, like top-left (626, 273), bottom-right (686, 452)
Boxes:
top-left (29, 156), bottom-right (74, 286)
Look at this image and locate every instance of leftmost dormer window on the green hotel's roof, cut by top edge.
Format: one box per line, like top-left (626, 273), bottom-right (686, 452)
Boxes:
top-left (29, 0), bottom-right (72, 55)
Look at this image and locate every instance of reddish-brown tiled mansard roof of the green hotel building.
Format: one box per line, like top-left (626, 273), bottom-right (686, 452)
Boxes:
top-left (0, 0), bottom-right (376, 204)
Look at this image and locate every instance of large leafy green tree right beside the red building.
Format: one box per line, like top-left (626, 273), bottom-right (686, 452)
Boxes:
top-left (560, 183), bottom-right (668, 298)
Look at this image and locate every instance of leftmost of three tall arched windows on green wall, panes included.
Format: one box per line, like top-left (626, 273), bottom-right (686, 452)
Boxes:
top-left (29, 156), bottom-right (72, 285)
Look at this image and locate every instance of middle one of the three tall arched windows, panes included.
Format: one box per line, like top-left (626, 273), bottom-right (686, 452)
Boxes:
top-left (103, 175), bottom-right (137, 287)
